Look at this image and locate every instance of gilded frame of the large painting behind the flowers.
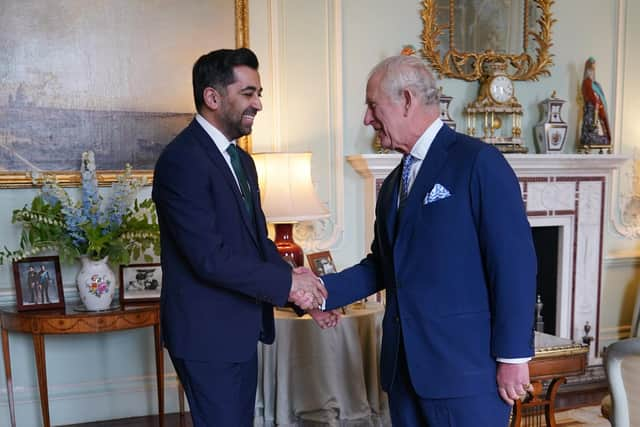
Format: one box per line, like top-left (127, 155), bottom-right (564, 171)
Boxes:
top-left (0, 0), bottom-right (251, 189)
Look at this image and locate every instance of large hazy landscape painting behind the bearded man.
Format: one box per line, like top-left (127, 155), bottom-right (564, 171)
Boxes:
top-left (0, 0), bottom-right (247, 187)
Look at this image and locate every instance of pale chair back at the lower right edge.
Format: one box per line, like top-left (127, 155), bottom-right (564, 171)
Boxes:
top-left (605, 338), bottom-right (640, 427)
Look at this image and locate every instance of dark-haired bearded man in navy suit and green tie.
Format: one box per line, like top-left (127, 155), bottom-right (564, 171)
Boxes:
top-left (153, 49), bottom-right (327, 427)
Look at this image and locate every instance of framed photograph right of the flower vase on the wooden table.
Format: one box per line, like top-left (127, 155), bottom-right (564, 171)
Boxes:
top-left (120, 263), bottom-right (162, 304)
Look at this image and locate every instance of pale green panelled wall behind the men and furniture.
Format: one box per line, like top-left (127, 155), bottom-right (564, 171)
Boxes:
top-left (0, 0), bottom-right (640, 427)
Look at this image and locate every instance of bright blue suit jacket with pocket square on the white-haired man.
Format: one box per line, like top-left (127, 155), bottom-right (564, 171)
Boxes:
top-left (323, 126), bottom-right (536, 398)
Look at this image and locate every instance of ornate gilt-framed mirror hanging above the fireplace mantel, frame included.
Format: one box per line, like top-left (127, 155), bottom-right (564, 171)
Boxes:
top-left (422, 0), bottom-right (556, 81)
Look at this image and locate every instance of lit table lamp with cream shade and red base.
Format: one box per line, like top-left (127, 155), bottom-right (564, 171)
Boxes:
top-left (252, 153), bottom-right (330, 267)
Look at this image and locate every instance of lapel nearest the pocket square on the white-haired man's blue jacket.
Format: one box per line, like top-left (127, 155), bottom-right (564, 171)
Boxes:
top-left (395, 125), bottom-right (455, 251)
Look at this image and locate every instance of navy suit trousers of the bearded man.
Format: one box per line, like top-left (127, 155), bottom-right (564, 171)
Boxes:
top-left (170, 352), bottom-right (258, 427)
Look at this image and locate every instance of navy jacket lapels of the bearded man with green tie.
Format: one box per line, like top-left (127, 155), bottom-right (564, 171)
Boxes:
top-left (190, 120), bottom-right (260, 247)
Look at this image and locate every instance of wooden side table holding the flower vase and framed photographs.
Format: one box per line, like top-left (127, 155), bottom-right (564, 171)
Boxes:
top-left (0, 304), bottom-right (164, 427)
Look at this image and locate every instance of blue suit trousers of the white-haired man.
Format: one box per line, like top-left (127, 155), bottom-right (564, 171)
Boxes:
top-left (388, 339), bottom-right (511, 427)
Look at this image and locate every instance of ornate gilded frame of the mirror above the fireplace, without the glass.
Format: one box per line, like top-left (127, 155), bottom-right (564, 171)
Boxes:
top-left (422, 0), bottom-right (556, 81)
